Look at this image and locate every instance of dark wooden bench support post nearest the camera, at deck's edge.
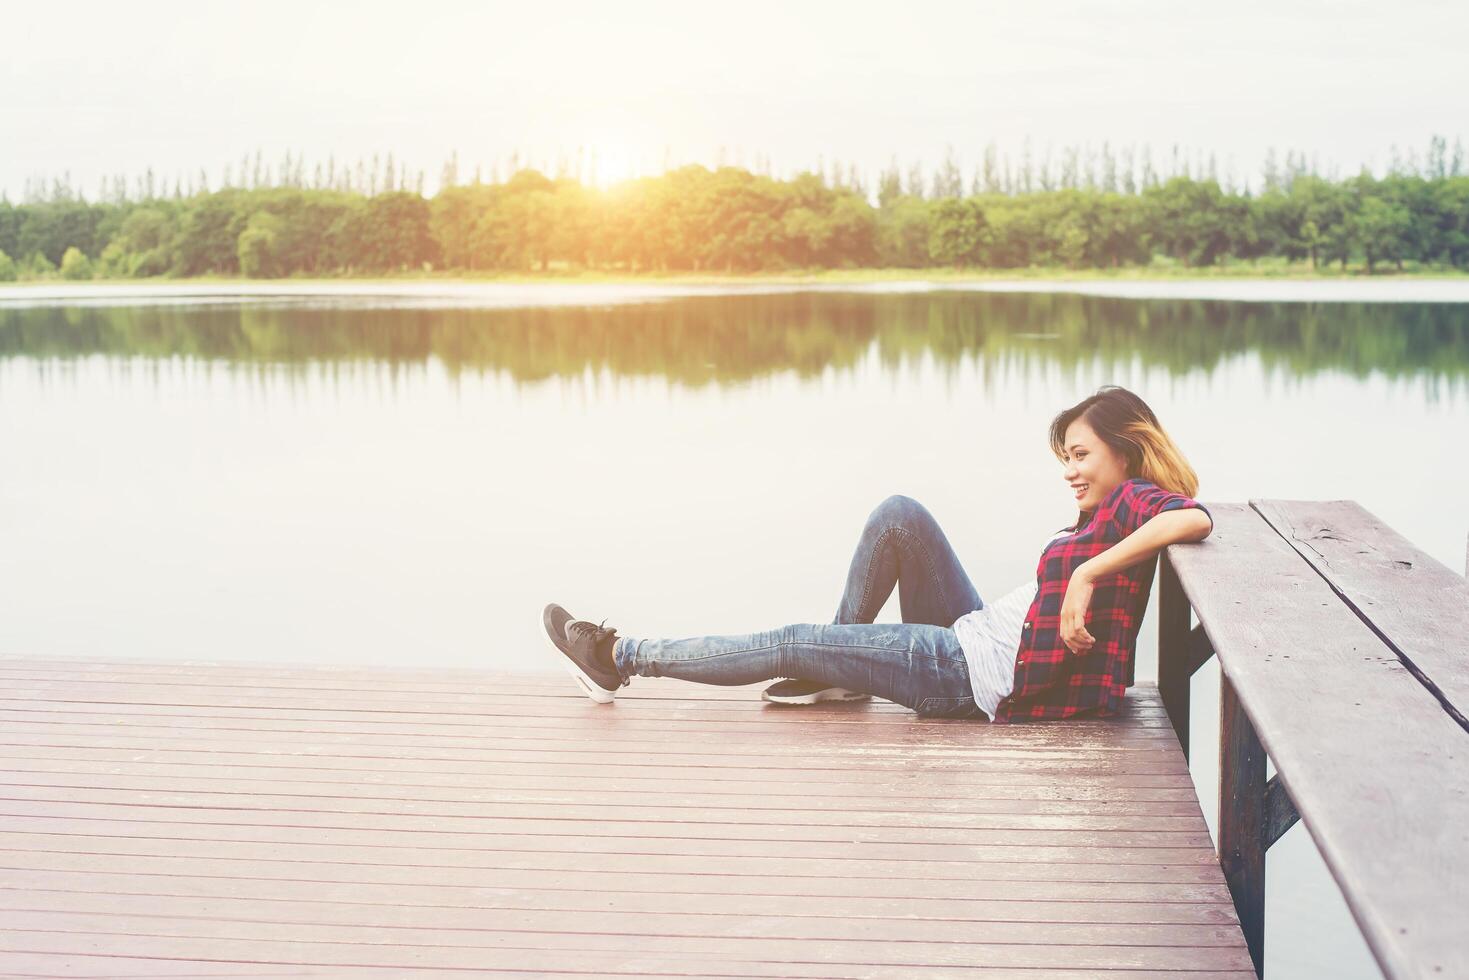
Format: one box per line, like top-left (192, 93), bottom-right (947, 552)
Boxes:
top-left (1218, 671), bottom-right (1269, 976)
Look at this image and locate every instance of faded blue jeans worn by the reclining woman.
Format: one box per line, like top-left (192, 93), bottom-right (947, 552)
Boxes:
top-left (613, 495), bottom-right (986, 718)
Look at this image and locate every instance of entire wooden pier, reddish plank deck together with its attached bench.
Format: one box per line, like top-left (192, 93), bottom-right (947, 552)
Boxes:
top-left (0, 501), bottom-right (1469, 980)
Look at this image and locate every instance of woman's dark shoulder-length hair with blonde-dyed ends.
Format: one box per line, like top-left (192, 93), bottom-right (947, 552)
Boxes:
top-left (1050, 385), bottom-right (1199, 497)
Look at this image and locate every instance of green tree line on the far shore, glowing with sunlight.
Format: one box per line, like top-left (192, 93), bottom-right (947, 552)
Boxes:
top-left (0, 137), bottom-right (1469, 281)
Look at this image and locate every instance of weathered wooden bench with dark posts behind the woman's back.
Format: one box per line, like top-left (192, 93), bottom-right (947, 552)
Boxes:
top-left (1159, 500), bottom-right (1469, 977)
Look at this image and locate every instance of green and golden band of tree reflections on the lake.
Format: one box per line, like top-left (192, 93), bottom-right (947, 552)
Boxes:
top-left (0, 292), bottom-right (1469, 400)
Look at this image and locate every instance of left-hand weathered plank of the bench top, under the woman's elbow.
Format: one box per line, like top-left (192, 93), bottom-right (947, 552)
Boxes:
top-left (1169, 504), bottom-right (1469, 977)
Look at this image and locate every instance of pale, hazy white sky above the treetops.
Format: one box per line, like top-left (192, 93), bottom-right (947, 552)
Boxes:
top-left (0, 0), bottom-right (1469, 200)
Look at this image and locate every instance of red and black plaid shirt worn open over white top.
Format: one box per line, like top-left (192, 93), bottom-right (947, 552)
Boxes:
top-left (995, 478), bottom-right (1213, 723)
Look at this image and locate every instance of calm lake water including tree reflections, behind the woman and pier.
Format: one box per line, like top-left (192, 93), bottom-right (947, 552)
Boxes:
top-left (0, 291), bottom-right (1469, 977)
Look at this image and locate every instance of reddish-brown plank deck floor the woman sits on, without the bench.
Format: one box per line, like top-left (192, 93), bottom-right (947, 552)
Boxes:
top-left (0, 658), bottom-right (1253, 980)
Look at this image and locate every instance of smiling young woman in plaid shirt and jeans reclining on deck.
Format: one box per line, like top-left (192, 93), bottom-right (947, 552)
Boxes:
top-left (544, 385), bottom-right (1213, 721)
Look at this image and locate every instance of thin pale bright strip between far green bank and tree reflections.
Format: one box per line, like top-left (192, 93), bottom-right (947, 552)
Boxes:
top-left (0, 270), bottom-right (1469, 307)
